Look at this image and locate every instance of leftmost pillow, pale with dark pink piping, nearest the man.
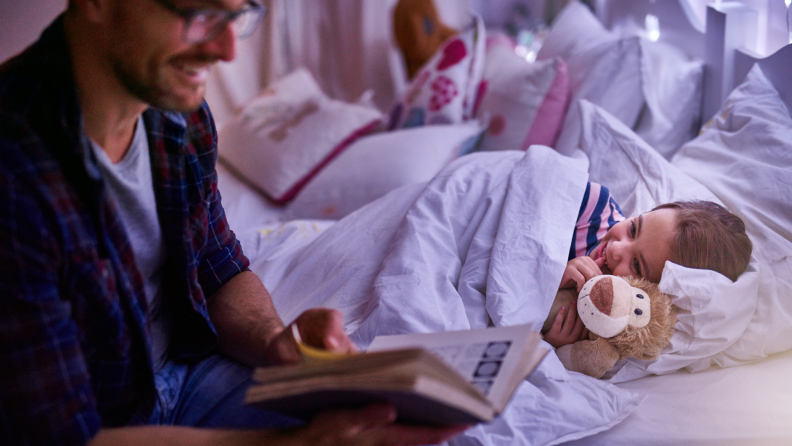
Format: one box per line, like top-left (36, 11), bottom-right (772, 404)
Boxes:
top-left (218, 69), bottom-right (382, 204)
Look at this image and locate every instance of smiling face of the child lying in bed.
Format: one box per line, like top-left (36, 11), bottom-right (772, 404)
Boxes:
top-left (590, 209), bottom-right (677, 283)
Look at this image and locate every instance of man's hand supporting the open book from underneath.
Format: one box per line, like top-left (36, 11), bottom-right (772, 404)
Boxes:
top-left (295, 405), bottom-right (468, 446)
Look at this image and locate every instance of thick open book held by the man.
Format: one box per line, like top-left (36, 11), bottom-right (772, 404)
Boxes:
top-left (245, 325), bottom-right (547, 425)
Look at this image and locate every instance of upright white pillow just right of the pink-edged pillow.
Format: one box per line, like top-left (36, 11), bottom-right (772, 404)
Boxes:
top-left (537, 0), bottom-right (644, 155)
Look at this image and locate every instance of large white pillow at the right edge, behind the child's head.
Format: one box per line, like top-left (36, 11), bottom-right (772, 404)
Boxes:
top-left (672, 65), bottom-right (792, 366)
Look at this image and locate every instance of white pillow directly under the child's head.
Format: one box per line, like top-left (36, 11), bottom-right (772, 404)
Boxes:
top-left (580, 101), bottom-right (760, 382)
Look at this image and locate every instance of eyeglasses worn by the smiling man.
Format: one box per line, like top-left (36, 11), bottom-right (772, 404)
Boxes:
top-left (154, 0), bottom-right (267, 43)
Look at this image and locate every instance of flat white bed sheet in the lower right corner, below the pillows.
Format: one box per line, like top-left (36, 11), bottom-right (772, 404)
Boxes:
top-left (569, 351), bottom-right (792, 446)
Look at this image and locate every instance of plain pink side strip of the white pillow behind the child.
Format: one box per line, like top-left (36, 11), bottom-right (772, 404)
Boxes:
top-left (522, 59), bottom-right (569, 150)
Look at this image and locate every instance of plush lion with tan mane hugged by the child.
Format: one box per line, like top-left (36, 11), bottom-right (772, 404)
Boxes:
top-left (542, 275), bottom-right (676, 378)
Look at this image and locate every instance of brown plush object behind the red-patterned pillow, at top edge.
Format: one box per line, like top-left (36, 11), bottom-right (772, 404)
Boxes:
top-left (393, 0), bottom-right (457, 79)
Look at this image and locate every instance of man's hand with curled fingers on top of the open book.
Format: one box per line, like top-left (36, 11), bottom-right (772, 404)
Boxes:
top-left (266, 308), bottom-right (357, 364)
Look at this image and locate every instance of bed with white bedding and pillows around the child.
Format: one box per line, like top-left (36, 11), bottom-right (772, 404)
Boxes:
top-left (208, 0), bottom-right (792, 445)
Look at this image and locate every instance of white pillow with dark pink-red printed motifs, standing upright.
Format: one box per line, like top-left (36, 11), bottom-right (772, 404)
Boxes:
top-left (388, 15), bottom-right (486, 130)
